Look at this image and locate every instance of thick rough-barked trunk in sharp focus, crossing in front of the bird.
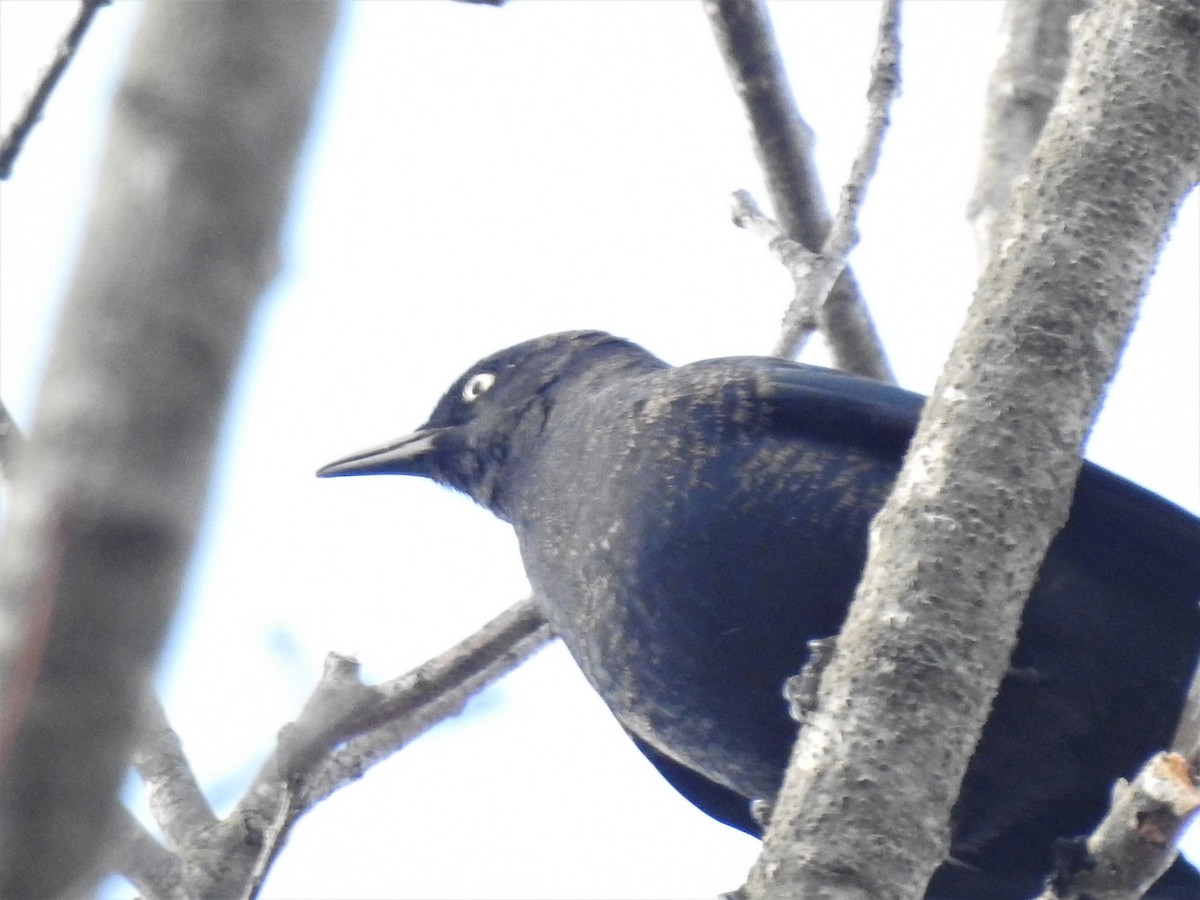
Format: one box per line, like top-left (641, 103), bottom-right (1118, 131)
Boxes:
top-left (746, 0), bottom-right (1200, 900)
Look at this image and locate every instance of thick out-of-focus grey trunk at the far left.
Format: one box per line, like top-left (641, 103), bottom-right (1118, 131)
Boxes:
top-left (0, 2), bottom-right (336, 896)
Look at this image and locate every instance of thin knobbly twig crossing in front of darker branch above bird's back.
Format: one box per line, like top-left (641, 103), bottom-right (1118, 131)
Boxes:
top-left (772, 0), bottom-right (900, 358)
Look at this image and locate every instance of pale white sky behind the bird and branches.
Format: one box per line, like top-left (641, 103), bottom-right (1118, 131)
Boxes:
top-left (0, 0), bottom-right (1200, 898)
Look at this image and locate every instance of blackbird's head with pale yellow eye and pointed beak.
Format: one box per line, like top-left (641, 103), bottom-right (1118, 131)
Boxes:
top-left (317, 331), bottom-right (661, 520)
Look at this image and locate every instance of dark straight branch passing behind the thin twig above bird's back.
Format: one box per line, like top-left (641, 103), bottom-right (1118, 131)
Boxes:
top-left (704, 0), bottom-right (895, 382)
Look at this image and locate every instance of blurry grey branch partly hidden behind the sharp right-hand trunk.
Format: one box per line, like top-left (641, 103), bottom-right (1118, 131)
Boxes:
top-left (967, 0), bottom-right (1088, 264)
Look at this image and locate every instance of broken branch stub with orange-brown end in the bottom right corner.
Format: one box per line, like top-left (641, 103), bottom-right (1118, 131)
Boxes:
top-left (1038, 754), bottom-right (1200, 900)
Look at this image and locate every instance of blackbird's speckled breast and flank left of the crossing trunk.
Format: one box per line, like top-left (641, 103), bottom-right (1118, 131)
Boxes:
top-left (514, 391), bottom-right (890, 797)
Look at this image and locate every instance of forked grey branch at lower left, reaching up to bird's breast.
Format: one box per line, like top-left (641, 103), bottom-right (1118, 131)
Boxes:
top-left (119, 599), bottom-right (552, 900)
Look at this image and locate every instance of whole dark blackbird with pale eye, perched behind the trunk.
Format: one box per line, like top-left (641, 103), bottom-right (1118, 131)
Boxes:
top-left (318, 331), bottom-right (1200, 900)
